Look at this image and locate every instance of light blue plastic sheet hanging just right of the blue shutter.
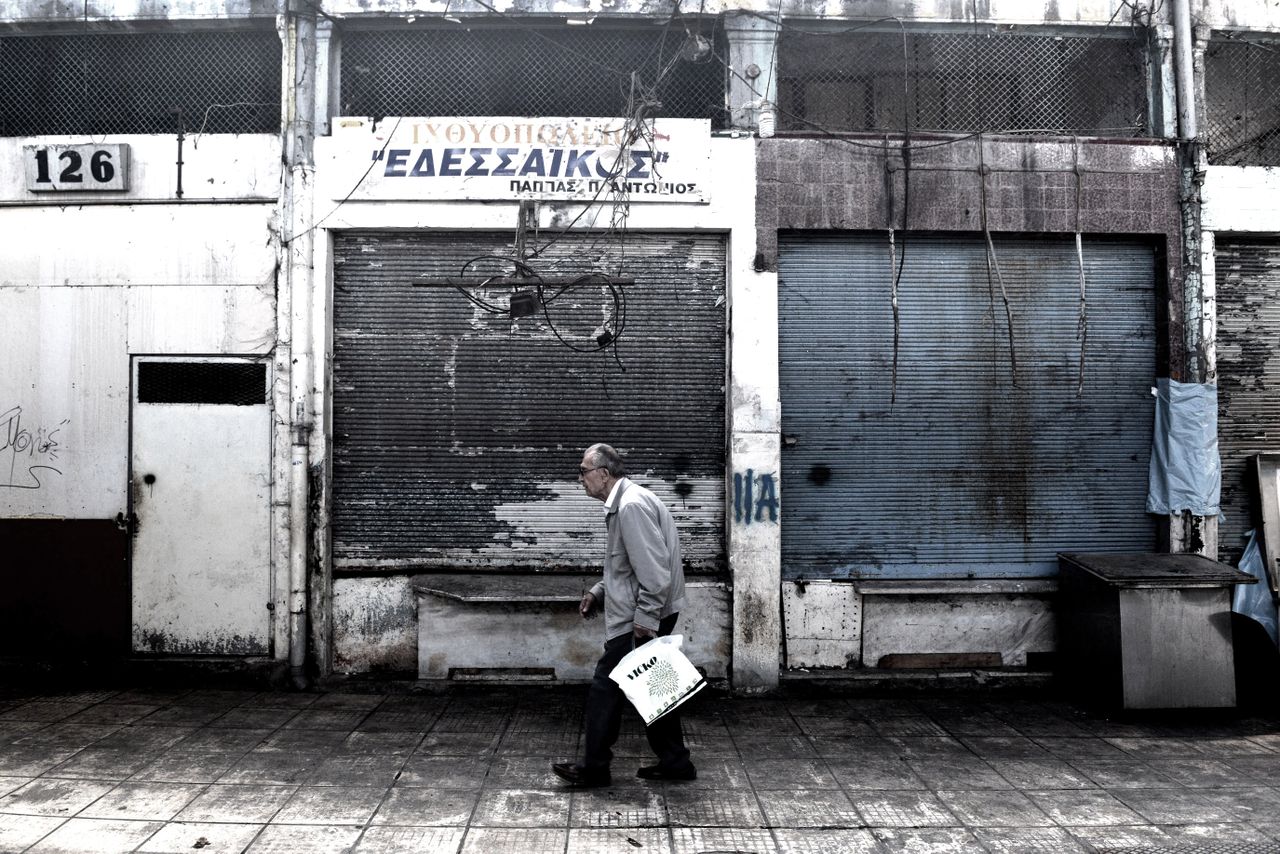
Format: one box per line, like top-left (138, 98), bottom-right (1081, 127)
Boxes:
top-left (1147, 378), bottom-right (1222, 516)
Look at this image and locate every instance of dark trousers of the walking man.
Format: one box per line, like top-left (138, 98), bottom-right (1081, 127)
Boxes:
top-left (582, 613), bottom-right (689, 771)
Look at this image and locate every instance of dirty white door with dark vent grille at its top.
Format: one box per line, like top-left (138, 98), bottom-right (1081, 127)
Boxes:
top-left (129, 356), bottom-right (271, 656)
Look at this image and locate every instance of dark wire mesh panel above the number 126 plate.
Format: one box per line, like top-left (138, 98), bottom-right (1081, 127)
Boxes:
top-left (0, 28), bottom-right (282, 137)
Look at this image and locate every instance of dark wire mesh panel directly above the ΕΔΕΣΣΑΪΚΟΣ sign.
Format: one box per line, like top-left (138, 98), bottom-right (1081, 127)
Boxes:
top-left (342, 26), bottom-right (727, 127)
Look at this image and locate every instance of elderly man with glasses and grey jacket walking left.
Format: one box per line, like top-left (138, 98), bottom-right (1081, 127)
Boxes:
top-left (552, 444), bottom-right (698, 787)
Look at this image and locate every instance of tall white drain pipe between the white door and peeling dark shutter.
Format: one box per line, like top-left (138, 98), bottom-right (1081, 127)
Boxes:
top-left (282, 0), bottom-right (316, 688)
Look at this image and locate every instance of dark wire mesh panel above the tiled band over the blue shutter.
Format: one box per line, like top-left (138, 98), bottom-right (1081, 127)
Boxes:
top-left (777, 31), bottom-right (1149, 137)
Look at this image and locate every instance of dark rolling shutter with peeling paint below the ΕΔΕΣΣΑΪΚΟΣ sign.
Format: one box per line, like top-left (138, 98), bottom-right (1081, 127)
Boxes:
top-left (333, 232), bottom-right (726, 571)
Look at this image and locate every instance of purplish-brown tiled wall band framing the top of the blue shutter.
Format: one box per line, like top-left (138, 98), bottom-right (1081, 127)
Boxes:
top-left (755, 137), bottom-right (1184, 375)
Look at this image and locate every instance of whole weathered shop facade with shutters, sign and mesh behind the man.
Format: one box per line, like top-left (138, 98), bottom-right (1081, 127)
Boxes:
top-left (0, 4), bottom-right (1280, 690)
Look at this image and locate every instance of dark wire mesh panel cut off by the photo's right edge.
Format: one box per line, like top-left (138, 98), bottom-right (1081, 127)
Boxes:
top-left (1204, 36), bottom-right (1280, 166)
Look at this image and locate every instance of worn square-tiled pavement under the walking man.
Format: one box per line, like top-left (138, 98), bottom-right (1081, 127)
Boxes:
top-left (0, 688), bottom-right (1280, 854)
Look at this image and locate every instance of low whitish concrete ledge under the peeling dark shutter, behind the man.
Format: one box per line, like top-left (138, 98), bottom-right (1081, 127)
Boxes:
top-left (413, 572), bottom-right (732, 681)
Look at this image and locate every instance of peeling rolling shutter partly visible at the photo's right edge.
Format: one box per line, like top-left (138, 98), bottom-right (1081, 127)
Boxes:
top-left (1213, 237), bottom-right (1280, 565)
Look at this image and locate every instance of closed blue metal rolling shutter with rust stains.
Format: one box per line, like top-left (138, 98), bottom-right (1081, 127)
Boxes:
top-left (778, 233), bottom-right (1156, 577)
